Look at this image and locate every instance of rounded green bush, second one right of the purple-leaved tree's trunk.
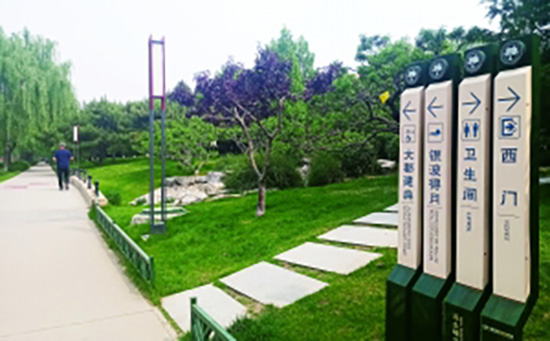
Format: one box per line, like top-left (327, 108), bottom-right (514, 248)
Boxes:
top-left (308, 152), bottom-right (344, 186)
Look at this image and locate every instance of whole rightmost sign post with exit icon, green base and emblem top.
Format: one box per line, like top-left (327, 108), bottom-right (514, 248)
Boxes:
top-left (481, 35), bottom-right (540, 340)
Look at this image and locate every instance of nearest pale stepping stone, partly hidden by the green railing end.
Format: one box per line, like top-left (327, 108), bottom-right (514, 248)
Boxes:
top-left (162, 284), bottom-right (246, 332)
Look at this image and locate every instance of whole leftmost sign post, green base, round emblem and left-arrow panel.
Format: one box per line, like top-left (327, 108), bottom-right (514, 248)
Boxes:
top-left (386, 63), bottom-right (427, 341)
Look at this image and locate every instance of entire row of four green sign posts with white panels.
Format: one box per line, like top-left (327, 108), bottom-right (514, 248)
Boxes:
top-left (386, 35), bottom-right (540, 341)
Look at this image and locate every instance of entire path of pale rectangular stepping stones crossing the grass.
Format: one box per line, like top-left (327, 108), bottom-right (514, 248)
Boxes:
top-left (162, 204), bottom-right (399, 331)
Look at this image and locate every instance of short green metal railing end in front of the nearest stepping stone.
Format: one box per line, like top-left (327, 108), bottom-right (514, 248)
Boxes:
top-left (191, 297), bottom-right (236, 341)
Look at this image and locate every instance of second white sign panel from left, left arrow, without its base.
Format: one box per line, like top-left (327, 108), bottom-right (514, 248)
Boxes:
top-left (423, 81), bottom-right (453, 278)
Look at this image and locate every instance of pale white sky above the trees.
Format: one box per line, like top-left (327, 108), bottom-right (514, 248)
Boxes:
top-left (0, 0), bottom-right (497, 103)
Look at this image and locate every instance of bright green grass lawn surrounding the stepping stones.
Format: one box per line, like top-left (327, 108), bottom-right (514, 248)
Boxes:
top-left (87, 160), bottom-right (550, 341)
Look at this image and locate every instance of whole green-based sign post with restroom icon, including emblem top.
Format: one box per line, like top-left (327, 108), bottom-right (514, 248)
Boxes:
top-left (443, 45), bottom-right (497, 340)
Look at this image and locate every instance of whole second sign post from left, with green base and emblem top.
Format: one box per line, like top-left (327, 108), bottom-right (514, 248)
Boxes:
top-left (411, 55), bottom-right (459, 341)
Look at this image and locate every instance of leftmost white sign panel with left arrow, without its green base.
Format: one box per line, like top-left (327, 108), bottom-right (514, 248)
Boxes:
top-left (397, 86), bottom-right (424, 269)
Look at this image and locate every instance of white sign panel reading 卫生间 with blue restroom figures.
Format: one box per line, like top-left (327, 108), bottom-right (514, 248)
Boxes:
top-left (456, 74), bottom-right (491, 290)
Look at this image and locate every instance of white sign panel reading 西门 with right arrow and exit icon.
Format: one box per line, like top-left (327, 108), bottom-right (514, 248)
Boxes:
top-left (493, 66), bottom-right (531, 302)
